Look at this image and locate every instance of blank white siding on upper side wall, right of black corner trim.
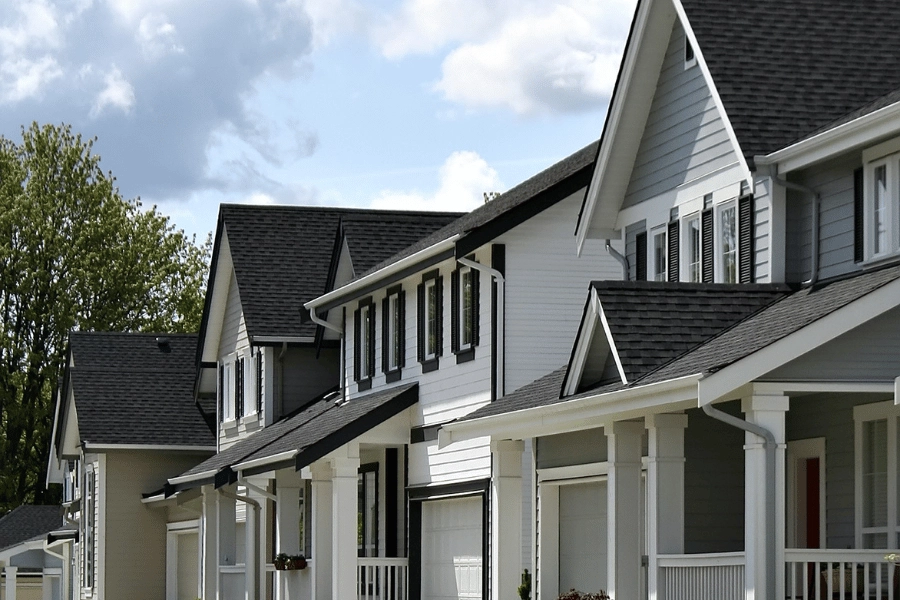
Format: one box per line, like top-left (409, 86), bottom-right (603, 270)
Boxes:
top-left (497, 190), bottom-right (622, 393)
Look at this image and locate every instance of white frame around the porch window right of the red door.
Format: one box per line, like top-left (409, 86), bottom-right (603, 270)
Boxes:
top-left (853, 401), bottom-right (900, 548)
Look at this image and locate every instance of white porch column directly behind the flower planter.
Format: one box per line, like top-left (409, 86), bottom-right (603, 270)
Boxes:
top-left (275, 469), bottom-right (309, 600)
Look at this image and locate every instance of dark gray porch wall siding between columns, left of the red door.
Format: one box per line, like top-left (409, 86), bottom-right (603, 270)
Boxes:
top-left (684, 402), bottom-right (744, 553)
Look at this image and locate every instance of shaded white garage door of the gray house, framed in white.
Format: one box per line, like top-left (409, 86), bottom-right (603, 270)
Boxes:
top-left (559, 481), bottom-right (606, 593)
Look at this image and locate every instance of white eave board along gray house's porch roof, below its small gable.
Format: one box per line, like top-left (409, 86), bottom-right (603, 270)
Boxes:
top-left (438, 373), bottom-right (702, 447)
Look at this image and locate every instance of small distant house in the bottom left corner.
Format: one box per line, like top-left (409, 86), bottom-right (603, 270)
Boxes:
top-left (0, 505), bottom-right (64, 600)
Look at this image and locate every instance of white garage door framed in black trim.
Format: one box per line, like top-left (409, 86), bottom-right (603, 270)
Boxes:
top-left (422, 496), bottom-right (482, 600)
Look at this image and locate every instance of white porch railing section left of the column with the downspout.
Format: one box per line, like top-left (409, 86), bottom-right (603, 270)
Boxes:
top-left (658, 552), bottom-right (744, 600)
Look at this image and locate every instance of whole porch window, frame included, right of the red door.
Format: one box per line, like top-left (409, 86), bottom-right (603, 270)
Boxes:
top-left (853, 402), bottom-right (900, 548)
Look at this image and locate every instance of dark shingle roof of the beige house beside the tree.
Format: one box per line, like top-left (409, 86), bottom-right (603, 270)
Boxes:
top-left (67, 332), bottom-right (215, 446)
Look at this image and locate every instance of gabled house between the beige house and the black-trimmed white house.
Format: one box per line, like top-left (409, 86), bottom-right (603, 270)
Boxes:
top-left (155, 205), bottom-right (460, 598)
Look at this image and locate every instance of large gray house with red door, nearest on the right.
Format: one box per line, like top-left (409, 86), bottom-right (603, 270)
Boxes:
top-left (439, 0), bottom-right (900, 600)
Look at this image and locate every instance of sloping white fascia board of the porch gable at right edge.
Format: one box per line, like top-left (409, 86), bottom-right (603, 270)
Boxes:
top-left (697, 279), bottom-right (900, 406)
